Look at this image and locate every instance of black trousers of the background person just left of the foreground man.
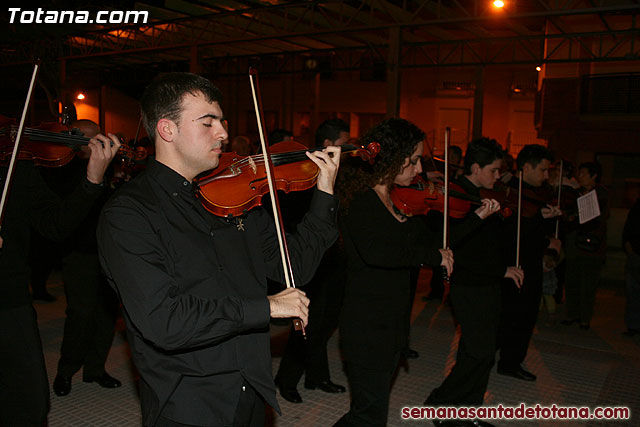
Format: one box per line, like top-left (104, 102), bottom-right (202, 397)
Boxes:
top-left (58, 252), bottom-right (117, 378)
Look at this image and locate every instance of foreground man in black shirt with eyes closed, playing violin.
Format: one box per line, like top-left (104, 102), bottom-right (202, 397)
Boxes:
top-left (98, 73), bottom-right (340, 426)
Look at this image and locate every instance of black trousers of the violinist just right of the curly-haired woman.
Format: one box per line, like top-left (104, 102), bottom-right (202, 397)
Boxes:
top-left (427, 283), bottom-right (501, 406)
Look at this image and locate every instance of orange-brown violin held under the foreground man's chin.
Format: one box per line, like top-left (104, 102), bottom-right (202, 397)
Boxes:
top-left (194, 141), bottom-right (380, 217)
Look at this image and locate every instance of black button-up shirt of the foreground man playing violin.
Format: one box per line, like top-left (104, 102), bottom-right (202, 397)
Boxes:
top-left (98, 161), bottom-right (338, 425)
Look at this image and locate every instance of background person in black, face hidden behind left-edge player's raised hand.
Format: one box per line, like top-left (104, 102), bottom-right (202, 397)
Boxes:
top-left (50, 119), bottom-right (122, 396)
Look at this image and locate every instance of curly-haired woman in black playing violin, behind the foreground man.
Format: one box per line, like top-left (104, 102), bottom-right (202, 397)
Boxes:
top-left (336, 119), bottom-right (453, 426)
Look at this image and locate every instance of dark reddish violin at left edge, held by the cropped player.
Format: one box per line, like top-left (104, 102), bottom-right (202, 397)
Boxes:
top-left (0, 116), bottom-right (147, 167)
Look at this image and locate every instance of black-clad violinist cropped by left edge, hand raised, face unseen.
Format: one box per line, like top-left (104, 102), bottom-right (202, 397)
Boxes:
top-left (0, 134), bottom-right (120, 426)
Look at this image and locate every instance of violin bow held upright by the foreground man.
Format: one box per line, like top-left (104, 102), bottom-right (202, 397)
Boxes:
top-left (249, 67), bottom-right (306, 338)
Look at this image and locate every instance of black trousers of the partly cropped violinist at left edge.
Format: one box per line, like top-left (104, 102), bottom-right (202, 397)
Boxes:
top-left (0, 305), bottom-right (49, 426)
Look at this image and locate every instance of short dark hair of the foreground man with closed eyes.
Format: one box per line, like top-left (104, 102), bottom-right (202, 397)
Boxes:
top-left (140, 73), bottom-right (222, 139)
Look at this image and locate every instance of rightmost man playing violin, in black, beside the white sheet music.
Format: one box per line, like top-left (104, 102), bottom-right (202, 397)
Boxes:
top-left (498, 144), bottom-right (561, 381)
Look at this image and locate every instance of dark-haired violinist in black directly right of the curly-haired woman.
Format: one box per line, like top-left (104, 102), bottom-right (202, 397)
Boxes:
top-left (425, 138), bottom-right (523, 425)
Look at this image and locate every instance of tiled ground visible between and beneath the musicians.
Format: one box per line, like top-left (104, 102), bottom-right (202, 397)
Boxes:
top-left (35, 275), bottom-right (640, 427)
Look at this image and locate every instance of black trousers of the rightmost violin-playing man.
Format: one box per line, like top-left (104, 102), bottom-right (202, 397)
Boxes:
top-left (498, 276), bottom-right (542, 369)
